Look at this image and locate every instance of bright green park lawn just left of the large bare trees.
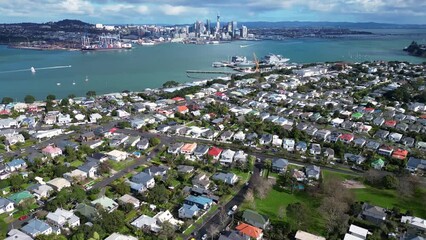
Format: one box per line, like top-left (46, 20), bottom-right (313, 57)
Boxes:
top-left (248, 187), bottom-right (325, 235)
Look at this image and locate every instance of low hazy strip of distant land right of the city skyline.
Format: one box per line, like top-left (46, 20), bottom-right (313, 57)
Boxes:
top-left (241, 21), bottom-right (426, 29)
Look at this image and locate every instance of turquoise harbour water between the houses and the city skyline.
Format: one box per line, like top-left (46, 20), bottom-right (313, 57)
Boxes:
top-left (0, 32), bottom-right (426, 100)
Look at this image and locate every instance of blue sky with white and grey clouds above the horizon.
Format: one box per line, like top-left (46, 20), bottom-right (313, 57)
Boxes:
top-left (0, 0), bottom-right (426, 24)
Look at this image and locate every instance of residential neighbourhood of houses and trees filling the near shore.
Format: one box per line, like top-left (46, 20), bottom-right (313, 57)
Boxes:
top-left (0, 62), bottom-right (426, 240)
